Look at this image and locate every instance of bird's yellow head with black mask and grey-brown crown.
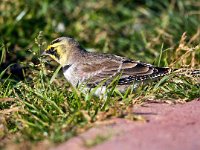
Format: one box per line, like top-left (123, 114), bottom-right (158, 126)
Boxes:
top-left (42, 37), bottom-right (80, 66)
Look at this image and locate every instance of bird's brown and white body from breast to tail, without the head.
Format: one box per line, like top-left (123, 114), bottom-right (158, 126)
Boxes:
top-left (65, 53), bottom-right (169, 87)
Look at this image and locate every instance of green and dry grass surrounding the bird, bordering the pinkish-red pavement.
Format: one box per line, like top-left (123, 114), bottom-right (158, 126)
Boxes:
top-left (0, 0), bottom-right (200, 148)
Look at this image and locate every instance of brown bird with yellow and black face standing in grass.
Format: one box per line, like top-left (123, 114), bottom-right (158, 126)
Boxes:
top-left (42, 37), bottom-right (198, 96)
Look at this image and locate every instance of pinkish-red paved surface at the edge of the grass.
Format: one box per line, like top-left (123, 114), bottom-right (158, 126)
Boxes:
top-left (55, 100), bottom-right (200, 150)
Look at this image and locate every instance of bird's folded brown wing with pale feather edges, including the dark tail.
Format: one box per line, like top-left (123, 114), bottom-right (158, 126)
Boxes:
top-left (78, 57), bottom-right (168, 87)
